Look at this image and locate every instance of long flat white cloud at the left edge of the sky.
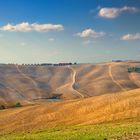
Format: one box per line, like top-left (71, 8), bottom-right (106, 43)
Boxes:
top-left (0, 22), bottom-right (64, 32)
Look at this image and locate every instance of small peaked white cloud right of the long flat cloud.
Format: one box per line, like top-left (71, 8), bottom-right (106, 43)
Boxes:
top-left (77, 28), bottom-right (105, 38)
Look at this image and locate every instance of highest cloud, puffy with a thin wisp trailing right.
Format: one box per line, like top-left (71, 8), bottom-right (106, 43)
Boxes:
top-left (98, 6), bottom-right (139, 19)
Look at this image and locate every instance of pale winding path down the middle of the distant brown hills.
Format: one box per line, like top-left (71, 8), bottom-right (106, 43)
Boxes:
top-left (69, 67), bottom-right (84, 98)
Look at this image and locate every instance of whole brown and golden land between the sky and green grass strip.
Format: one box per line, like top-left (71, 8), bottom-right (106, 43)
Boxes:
top-left (0, 61), bottom-right (140, 137)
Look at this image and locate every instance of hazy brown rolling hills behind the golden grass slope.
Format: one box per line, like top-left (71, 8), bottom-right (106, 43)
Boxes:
top-left (0, 62), bottom-right (140, 104)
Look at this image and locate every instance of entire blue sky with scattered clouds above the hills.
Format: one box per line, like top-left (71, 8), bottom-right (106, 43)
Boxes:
top-left (0, 0), bottom-right (140, 63)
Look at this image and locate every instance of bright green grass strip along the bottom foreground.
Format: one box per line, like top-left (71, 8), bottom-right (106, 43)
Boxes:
top-left (0, 120), bottom-right (140, 140)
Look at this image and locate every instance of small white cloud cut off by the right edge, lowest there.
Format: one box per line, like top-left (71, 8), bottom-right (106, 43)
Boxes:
top-left (121, 33), bottom-right (140, 41)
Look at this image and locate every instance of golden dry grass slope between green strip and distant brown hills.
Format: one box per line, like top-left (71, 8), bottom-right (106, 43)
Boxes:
top-left (0, 89), bottom-right (140, 133)
